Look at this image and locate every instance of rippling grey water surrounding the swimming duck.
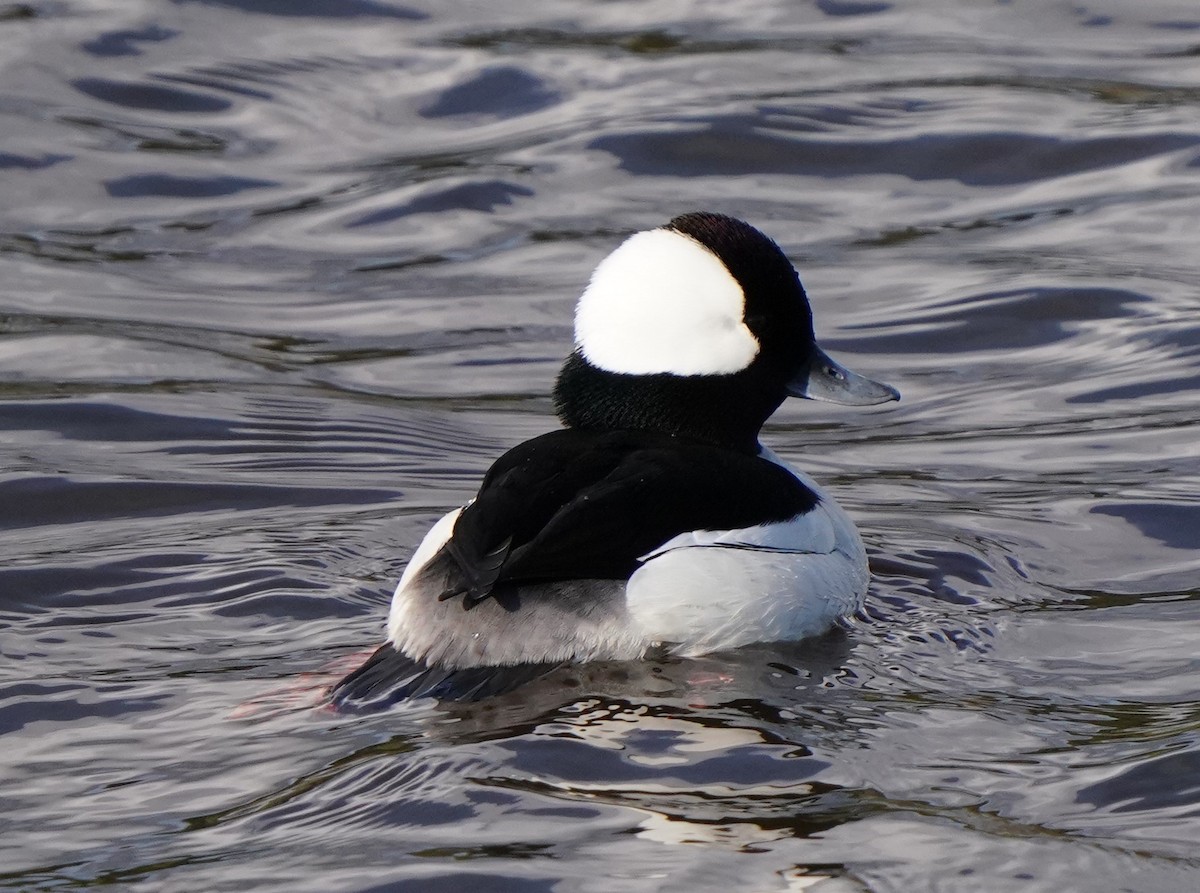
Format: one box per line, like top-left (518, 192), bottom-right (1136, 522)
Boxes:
top-left (0, 0), bottom-right (1200, 893)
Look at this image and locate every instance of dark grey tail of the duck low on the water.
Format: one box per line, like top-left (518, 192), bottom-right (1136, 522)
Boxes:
top-left (330, 642), bottom-right (559, 712)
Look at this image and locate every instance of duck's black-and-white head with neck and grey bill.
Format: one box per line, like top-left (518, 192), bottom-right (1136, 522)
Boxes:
top-left (554, 212), bottom-right (900, 450)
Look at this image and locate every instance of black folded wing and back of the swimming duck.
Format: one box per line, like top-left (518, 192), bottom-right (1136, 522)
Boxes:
top-left (442, 428), bottom-right (817, 607)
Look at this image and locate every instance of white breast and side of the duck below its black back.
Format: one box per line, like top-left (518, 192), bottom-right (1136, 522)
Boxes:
top-left (626, 450), bottom-right (870, 657)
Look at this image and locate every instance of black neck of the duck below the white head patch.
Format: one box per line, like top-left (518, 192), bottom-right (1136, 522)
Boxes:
top-left (554, 350), bottom-right (785, 454)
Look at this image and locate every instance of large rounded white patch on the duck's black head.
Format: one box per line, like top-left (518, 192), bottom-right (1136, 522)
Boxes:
top-left (575, 229), bottom-right (758, 376)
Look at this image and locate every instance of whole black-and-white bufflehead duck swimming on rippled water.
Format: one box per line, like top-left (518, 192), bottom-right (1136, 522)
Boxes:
top-left (332, 212), bottom-right (900, 705)
